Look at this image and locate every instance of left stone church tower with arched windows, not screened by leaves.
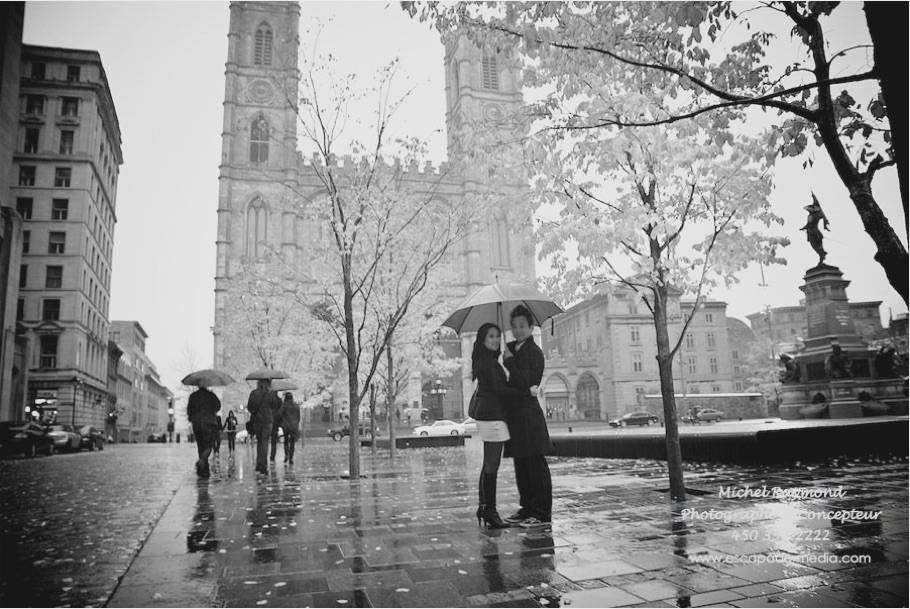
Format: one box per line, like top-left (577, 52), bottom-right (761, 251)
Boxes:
top-left (213, 2), bottom-right (300, 367)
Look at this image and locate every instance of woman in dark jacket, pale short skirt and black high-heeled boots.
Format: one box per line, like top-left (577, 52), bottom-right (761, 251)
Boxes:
top-left (471, 324), bottom-right (530, 529)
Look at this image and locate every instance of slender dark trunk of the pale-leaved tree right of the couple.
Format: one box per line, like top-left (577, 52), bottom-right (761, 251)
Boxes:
top-left (654, 286), bottom-right (686, 501)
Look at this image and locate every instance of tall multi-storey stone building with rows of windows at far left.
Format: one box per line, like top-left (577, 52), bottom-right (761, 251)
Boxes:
top-left (11, 45), bottom-right (123, 429)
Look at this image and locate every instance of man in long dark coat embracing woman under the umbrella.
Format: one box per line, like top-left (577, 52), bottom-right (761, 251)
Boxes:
top-left (503, 305), bottom-right (553, 527)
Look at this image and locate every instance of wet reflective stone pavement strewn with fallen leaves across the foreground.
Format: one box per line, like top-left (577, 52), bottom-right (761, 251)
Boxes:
top-left (0, 438), bottom-right (908, 607)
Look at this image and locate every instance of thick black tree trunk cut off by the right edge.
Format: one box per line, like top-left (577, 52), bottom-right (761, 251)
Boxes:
top-left (863, 2), bottom-right (908, 222)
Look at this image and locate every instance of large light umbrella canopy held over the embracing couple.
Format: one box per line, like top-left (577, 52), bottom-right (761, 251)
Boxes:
top-left (442, 283), bottom-right (563, 334)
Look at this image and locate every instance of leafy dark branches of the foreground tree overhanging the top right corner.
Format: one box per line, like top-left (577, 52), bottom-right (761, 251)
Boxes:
top-left (403, 2), bottom-right (908, 302)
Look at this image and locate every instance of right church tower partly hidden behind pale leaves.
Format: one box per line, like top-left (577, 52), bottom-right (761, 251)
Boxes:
top-left (445, 34), bottom-right (536, 295)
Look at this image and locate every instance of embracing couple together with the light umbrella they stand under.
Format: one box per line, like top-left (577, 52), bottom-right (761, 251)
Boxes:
top-left (443, 283), bottom-right (562, 528)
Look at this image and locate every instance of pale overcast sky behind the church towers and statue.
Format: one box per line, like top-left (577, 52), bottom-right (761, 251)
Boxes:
top-left (23, 1), bottom-right (906, 388)
